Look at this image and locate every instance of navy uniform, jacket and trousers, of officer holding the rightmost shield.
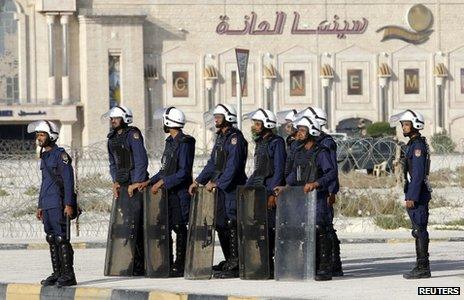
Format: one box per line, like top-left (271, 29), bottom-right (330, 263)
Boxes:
top-left (286, 144), bottom-right (337, 226)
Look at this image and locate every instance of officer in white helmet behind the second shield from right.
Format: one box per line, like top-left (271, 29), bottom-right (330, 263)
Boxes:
top-left (246, 108), bottom-right (286, 276)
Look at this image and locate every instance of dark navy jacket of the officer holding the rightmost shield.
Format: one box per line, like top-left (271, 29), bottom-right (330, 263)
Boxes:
top-left (286, 144), bottom-right (337, 197)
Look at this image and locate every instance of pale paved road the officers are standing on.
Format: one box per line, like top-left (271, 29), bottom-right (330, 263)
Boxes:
top-left (0, 242), bottom-right (464, 300)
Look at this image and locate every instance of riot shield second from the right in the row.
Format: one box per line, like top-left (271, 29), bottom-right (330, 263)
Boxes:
top-left (237, 186), bottom-right (270, 279)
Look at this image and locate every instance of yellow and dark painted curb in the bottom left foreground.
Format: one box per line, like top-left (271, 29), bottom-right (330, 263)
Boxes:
top-left (0, 283), bottom-right (265, 300)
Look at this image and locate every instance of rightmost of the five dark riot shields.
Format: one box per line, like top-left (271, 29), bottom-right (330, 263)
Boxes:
top-left (275, 186), bottom-right (316, 281)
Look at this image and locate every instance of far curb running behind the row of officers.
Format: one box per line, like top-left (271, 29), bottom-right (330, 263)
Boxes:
top-left (0, 236), bottom-right (464, 251)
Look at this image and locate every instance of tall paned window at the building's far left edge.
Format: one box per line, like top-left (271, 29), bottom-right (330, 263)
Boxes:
top-left (0, 0), bottom-right (19, 105)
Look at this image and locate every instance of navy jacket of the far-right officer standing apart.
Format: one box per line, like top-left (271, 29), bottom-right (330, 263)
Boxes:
top-left (404, 135), bottom-right (431, 202)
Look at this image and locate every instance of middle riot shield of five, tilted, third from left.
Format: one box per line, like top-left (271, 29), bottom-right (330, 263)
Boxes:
top-left (184, 188), bottom-right (217, 279)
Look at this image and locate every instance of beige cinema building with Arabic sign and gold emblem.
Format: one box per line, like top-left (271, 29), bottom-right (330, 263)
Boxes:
top-left (0, 0), bottom-right (464, 147)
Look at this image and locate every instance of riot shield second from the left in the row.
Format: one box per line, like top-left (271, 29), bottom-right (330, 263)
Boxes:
top-left (143, 188), bottom-right (170, 278)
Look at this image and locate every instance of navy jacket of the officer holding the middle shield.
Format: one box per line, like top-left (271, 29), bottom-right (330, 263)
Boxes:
top-left (196, 127), bottom-right (248, 192)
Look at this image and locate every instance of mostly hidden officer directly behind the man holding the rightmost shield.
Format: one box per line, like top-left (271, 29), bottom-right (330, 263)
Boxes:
top-left (296, 107), bottom-right (343, 276)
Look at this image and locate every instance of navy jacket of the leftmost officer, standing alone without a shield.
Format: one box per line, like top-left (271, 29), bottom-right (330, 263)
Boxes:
top-left (38, 145), bottom-right (76, 209)
